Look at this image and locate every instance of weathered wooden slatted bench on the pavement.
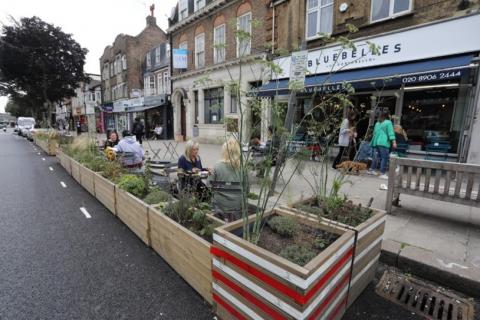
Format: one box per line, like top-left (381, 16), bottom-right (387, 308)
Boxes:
top-left (385, 156), bottom-right (480, 213)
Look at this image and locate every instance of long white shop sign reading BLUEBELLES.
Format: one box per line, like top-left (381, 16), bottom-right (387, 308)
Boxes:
top-left (272, 14), bottom-right (480, 79)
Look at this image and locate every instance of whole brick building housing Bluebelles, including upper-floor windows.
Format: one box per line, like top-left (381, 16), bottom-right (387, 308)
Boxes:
top-left (259, 0), bottom-right (480, 163)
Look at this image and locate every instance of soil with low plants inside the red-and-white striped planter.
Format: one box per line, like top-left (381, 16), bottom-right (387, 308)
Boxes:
top-left (257, 215), bottom-right (340, 267)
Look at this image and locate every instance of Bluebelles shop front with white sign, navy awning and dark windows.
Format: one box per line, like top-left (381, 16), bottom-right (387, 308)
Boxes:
top-left (259, 15), bottom-right (480, 161)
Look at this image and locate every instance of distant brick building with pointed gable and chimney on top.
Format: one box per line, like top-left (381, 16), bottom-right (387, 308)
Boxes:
top-left (100, 12), bottom-right (167, 132)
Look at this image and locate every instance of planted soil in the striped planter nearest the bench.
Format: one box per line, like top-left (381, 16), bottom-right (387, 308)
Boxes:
top-left (295, 198), bottom-right (374, 227)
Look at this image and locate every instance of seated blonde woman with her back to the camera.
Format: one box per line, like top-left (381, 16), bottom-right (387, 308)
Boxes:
top-left (208, 138), bottom-right (242, 222)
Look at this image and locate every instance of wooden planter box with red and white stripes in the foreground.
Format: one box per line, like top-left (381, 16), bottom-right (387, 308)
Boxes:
top-left (211, 209), bottom-right (355, 319)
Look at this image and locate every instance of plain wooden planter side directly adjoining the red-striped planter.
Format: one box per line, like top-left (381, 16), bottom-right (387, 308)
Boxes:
top-left (149, 206), bottom-right (223, 304)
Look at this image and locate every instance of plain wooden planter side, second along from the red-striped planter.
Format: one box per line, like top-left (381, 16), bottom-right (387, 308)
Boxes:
top-left (115, 187), bottom-right (150, 246)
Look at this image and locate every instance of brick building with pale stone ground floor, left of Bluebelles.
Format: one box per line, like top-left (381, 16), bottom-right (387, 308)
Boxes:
top-left (168, 0), bottom-right (271, 143)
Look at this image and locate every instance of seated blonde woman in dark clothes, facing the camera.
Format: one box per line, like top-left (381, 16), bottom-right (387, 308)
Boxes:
top-left (178, 140), bottom-right (209, 201)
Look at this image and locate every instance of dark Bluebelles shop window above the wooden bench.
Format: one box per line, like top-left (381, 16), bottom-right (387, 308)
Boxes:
top-left (401, 89), bottom-right (464, 153)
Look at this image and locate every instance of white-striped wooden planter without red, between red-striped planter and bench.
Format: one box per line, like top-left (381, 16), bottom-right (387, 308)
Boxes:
top-left (282, 199), bottom-right (386, 306)
